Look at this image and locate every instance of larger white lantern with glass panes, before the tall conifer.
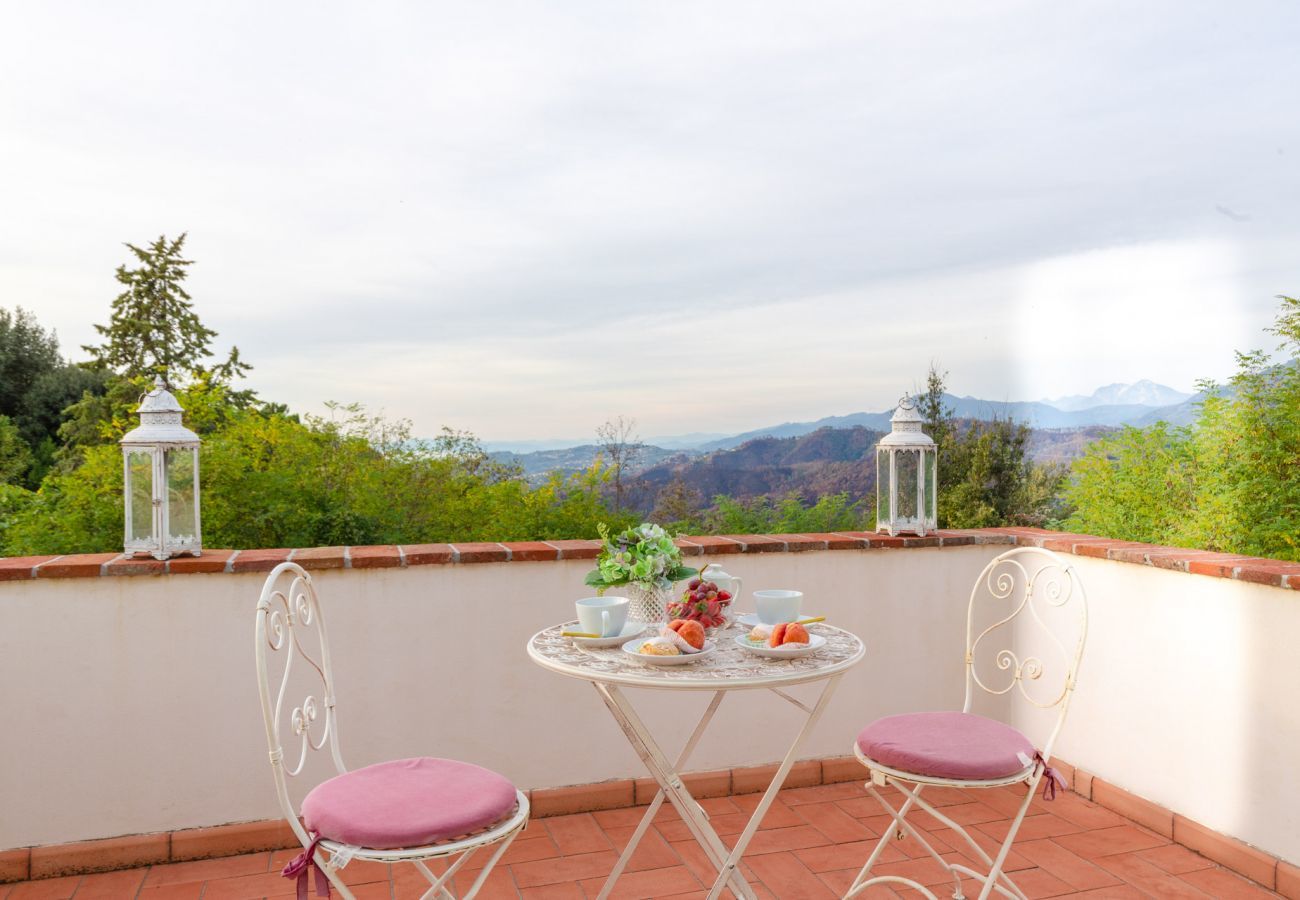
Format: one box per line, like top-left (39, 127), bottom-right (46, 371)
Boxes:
top-left (121, 376), bottom-right (203, 559)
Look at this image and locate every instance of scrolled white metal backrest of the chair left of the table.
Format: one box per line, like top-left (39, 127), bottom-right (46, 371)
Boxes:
top-left (255, 563), bottom-right (347, 821)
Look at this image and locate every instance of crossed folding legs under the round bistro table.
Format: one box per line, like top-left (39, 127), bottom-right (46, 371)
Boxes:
top-left (595, 675), bottom-right (841, 900)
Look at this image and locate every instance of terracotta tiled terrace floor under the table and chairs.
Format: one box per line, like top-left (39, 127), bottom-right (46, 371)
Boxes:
top-left (0, 783), bottom-right (1278, 900)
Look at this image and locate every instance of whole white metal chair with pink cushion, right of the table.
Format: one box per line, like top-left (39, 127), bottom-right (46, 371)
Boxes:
top-left (845, 548), bottom-right (1088, 900)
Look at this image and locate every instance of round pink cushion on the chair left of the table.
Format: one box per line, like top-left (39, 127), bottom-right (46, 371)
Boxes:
top-left (303, 757), bottom-right (516, 849)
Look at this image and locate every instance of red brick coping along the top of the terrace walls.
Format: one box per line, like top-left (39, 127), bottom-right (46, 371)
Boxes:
top-left (0, 528), bottom-right (1300, 590)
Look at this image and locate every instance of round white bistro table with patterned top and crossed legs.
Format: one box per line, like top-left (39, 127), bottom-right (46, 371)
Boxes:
top-left (528, 623), bottom-right (866, 900)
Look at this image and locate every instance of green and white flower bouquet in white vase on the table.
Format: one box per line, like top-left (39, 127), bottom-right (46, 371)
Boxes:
top-left (585, 522), bottom-right (698, 623)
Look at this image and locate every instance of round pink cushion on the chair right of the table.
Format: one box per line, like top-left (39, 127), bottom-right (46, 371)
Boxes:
top-left (858, 713), bottom-right (1035, 780)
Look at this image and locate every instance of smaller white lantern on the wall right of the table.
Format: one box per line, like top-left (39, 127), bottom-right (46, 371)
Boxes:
top-left (876, 397), bottom-right (939, 537)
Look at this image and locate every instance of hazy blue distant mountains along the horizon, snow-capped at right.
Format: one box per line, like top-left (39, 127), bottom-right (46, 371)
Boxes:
top-left (485, 380), bottom-right (1204, 478)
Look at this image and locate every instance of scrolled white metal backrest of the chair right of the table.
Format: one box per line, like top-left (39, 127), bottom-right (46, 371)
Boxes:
top-left (965, 548), bottom-right (1088, 756)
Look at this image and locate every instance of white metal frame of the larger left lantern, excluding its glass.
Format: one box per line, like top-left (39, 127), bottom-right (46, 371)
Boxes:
top-left (118, 376), bottom-right (203, 559)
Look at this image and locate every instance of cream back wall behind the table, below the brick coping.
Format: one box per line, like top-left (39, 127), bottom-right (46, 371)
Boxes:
top-left (0, 546), bottom-right (1002, 848)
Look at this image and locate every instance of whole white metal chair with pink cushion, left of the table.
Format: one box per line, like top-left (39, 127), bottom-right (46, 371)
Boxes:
top-left (256, 563), bottom-right (528, 900)
